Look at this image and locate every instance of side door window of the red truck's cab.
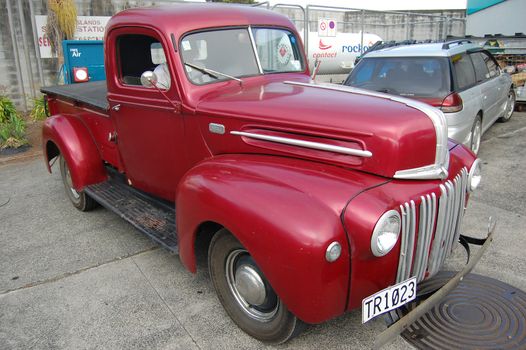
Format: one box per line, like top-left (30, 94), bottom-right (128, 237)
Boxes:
top-left (117, 34), bottom-right (170, 90)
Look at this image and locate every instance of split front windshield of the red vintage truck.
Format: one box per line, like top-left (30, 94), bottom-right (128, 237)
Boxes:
top-left (180, 28), bottom-right (304, 85)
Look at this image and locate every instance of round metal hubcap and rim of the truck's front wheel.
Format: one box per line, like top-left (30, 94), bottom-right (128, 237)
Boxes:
top-left (226, 249), bottom-right (279, 322)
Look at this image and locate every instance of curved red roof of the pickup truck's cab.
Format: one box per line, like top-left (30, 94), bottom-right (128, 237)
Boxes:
top-left (106, 3), bottom-right (295, 38)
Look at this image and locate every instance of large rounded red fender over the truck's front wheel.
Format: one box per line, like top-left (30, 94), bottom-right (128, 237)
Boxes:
top-left (176, 155), bottom-right (386, 323)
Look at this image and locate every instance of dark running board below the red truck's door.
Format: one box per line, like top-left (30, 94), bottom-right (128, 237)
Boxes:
top-left (84, 177), bottom-right (179, 253)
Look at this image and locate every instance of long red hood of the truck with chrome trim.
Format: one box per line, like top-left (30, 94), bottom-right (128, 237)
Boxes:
top-left (196, 80), bottom-right (448, 179)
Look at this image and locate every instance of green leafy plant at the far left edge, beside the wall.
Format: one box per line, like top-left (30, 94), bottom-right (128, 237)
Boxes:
top-left (0, 96), bottom-right (27, 148)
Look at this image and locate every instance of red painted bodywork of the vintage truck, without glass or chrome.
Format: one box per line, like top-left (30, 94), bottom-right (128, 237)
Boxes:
top-left (44, 4), bottom-right (474, 323)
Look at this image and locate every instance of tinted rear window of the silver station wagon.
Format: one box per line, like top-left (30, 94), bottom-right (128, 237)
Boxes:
top-left (345, 57), bottom-right (450, 97)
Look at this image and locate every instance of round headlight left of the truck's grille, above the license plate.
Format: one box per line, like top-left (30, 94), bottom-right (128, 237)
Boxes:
top-left (371, 210), bottom-right (401, 256)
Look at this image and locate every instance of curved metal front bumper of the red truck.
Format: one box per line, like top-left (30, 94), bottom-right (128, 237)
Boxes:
top-left (373, 218), bottom-right (495, 349)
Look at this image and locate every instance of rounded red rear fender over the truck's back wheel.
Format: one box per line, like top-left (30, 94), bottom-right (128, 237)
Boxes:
top-left (42, 114), bottom-right (107, 191)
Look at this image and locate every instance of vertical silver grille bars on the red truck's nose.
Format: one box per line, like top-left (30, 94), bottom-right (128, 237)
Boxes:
top-left (396, 168), bottom-right (468, 282)
